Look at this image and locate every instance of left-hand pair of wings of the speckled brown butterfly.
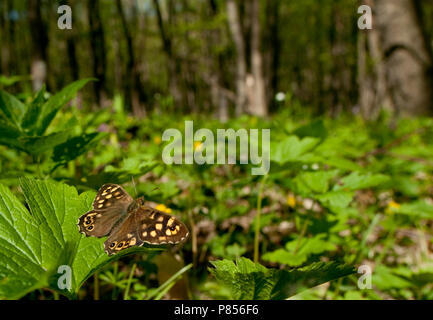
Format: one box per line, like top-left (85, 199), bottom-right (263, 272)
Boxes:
top-left (78, 184), bottom-right (134, 238)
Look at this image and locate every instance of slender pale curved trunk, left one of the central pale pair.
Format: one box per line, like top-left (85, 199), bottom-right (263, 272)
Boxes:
top-left (227, 0), bottom-right (247, 116)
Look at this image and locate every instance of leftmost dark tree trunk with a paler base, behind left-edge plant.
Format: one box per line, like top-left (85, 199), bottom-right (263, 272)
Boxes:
top-left (28, 0), bottom-right (48, 91)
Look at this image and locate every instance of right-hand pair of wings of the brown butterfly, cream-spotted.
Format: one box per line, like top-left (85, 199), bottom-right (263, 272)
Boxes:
top-left (104, 206), bottom-right (189, 255)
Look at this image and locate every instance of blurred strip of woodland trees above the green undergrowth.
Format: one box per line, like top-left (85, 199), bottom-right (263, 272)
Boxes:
top-left (0, 0), bottom-right (433, 120)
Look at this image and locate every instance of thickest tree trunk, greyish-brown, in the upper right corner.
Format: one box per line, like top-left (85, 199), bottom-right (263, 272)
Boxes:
top-left (376, 0), bottom-right (433, 115)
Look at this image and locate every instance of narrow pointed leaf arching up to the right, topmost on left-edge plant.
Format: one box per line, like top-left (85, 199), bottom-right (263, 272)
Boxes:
top-left (36, 78), bottom-right (95, 135)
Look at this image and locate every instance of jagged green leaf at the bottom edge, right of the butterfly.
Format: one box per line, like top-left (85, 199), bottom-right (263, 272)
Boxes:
top-left (210, 258), bottom-right (356, 300)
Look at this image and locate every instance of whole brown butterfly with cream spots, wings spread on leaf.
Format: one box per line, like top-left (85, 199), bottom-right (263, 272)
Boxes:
top-left (78, 184), bottom-right (189, 255)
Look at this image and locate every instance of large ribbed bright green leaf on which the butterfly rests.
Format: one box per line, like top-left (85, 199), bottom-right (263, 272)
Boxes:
top-left (0, 178), bottom-right (156, 299)
